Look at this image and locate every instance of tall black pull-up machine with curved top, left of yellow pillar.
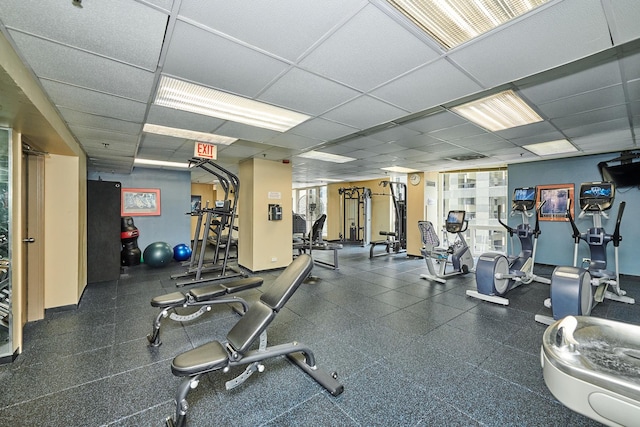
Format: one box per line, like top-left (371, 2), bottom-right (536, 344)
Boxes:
top-left (171, 158), bottom-right (246, 287)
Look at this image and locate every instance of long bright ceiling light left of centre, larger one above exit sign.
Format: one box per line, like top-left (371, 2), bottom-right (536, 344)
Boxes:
top-left (153, 76), bottom-right (309, 132)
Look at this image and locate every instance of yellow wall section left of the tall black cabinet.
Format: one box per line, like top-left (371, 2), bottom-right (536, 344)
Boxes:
top-left (44, 154), bottom-right (80, 308)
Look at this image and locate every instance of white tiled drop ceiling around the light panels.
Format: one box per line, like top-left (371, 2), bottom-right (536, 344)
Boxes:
top-left (0, 0), bottom-right (640, 183)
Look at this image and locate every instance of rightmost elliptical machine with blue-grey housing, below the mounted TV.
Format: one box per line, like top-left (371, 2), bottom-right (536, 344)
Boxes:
top-left (535, 182), bottom-right (635, 325)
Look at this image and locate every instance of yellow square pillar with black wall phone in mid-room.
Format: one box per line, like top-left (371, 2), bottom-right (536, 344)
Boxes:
top-left (238, 159), bottom-right (293, 271)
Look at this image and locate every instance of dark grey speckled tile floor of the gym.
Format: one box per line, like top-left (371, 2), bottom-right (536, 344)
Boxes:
top-left (0, 246), bottom-right (640, 426)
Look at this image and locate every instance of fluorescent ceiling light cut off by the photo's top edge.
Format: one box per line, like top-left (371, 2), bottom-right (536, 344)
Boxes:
top-left (387, 0), bottom-right (548, 49)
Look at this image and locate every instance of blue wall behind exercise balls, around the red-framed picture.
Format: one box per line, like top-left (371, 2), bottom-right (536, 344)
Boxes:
top-left (88, 168), bottom-right (192, 251)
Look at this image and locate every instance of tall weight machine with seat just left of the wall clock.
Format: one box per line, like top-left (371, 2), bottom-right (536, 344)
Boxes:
top-left (369, 181), bottom-right (407, 258)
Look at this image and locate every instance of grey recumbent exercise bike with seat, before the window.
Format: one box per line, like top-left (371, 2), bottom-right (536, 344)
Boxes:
top-left (418, 210), bottom-right (473, 283)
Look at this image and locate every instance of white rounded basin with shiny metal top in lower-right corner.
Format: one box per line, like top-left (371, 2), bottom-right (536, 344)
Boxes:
top-left (540, 316), bottom-right (640, 426)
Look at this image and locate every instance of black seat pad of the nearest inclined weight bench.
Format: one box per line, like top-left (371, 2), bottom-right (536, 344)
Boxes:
top-left (171, 341), bottom-right (229, 377)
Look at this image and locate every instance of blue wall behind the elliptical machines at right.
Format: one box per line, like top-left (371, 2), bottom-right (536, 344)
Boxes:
top-left (509, 152), bottom-right (640, 276)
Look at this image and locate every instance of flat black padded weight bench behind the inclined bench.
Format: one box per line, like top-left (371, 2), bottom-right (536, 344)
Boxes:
top-left (147, 277), bottom-right (263, 347)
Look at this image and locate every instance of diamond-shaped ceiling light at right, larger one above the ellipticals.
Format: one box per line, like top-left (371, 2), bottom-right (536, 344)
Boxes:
top-left (452, 90), bottom-right (542, 131)
